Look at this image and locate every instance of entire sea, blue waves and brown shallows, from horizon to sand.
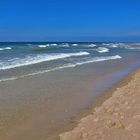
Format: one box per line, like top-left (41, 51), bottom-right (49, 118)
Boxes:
top-left (0, 42), bottom-right (140, 140)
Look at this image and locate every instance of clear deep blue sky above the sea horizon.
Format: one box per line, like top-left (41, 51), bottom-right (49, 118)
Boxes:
top-left (0, 0), bottom-right (140, 42)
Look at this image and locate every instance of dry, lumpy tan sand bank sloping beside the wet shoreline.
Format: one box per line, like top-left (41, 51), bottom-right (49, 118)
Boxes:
top-left (60, 70), bottom-right (140, 140)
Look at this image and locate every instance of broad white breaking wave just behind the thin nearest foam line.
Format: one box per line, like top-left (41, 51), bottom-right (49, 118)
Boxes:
top-left (0, 52), bottom-right (89, 70)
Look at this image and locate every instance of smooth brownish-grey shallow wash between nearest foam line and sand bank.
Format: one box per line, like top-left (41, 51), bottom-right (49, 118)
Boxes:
top-left (0, 59), bottom-right (139, 140)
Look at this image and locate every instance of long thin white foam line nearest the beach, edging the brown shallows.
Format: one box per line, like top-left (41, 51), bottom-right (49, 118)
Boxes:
top-left (0, 55), bottom-right (122, 82)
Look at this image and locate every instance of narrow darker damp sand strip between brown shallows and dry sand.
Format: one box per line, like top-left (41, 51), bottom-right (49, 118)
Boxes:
top-left (47, 67), bottom-right (140, 140)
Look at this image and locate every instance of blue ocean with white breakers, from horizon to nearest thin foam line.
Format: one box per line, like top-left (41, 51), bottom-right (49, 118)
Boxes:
top-left (0, 42), bottom-right (140, 81)
